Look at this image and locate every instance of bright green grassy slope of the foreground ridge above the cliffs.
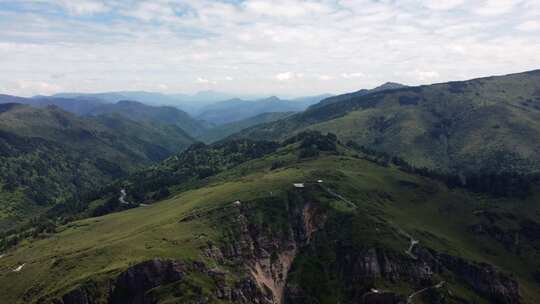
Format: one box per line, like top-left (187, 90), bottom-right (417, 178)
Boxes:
top-left (0, 148), bottom-right (540, 303)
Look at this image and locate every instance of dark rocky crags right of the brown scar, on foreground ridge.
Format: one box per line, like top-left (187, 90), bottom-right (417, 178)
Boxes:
top-left (285, 239), bottom-right (521, 304)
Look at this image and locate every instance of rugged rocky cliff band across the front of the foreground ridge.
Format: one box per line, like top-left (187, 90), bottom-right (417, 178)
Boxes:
top-left (48, 191), bottom-right (521, 304)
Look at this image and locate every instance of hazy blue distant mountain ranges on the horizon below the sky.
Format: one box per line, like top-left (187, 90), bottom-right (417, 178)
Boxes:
top-left (0, 91), bottom-right (331, 140)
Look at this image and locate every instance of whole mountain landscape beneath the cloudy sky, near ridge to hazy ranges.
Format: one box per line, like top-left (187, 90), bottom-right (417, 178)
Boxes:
top-left (0, 70), bottom-right (540, 304)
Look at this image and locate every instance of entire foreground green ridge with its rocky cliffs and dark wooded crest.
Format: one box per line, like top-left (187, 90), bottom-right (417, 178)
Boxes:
top-left (0, 133), bottom-right (540, 304)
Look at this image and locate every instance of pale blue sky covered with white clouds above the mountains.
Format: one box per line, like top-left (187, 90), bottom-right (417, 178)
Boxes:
top-left (0, 0), bottom-right (540, 96)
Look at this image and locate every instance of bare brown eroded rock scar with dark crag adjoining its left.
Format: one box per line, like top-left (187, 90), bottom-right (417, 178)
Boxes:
top-left (51, 194), bottom-right (324, 304)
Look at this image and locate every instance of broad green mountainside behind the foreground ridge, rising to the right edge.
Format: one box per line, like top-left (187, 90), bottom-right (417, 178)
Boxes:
top-left (233, 71), bottom-right (540, 173)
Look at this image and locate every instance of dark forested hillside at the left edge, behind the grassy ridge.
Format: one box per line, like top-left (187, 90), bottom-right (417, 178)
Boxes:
top-left (0, 104), bottom-right (193, 232)
